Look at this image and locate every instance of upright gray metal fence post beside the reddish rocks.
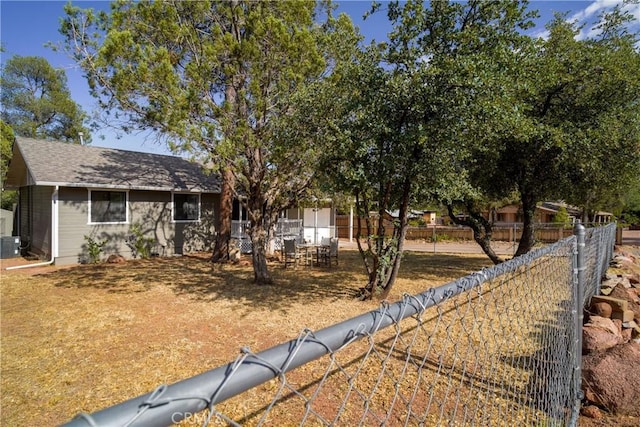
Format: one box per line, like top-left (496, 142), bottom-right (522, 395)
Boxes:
top-left (570, 223), bottom-right (586, 426)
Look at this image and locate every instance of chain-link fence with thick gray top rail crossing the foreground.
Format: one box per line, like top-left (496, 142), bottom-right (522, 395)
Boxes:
top-left (67, 224), bottom-right (615, 426)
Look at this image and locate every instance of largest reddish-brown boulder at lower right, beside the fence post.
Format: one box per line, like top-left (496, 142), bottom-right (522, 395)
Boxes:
top-left (582, 341), bottom-right (640, 416)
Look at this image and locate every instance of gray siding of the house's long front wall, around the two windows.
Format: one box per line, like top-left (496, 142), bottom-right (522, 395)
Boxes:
top-left (56, 188), bottom-right (219, 264)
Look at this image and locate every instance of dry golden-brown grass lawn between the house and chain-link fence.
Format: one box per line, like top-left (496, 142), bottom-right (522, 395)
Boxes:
top-left (0, 250), bottom-right (489, 426)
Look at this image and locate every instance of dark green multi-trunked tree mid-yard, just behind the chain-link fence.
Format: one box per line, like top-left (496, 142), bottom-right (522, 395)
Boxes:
top-left (302, 46), bottom-right (433, 298)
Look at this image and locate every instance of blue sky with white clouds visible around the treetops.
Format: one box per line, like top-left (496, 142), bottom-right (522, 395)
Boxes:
top-left (0, 0), bottom-right (640, 154)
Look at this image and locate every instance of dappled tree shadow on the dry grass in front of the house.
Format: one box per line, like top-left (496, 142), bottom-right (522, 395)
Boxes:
top-left (46, 250), bottom-right (486, 311)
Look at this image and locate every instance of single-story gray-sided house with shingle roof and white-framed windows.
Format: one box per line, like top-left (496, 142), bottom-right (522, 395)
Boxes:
top-left (5, 137), bottom-right (220, 264)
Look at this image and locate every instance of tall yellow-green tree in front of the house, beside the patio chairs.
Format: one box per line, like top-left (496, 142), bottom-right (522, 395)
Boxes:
top-left (61, 1), bottom-right (351, 284)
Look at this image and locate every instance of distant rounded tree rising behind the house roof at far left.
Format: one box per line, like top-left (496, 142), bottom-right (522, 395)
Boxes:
top-left (0, 55), bottom-right (91, 143)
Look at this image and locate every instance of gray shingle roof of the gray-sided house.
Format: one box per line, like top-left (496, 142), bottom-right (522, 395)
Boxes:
top-left (7, 137), bottom-right (220, 193)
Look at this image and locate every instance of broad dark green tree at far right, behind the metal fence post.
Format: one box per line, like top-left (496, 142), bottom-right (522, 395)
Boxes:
top-left (460, 6), bottom-right (640, 255)
